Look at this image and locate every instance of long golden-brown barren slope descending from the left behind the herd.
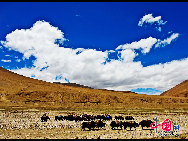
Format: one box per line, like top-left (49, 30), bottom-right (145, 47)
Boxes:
top-left (0, 68), bottom-right (188, 110)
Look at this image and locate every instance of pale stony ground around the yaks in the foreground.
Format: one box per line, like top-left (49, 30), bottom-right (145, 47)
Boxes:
top-left (0, 110), bottom-right (188, 139)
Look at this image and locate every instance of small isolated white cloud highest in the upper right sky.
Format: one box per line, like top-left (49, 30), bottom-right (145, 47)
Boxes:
top-left (138, 14), bottom-right (167, 31)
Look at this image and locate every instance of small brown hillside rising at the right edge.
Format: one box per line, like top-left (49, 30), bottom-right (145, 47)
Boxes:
top-left (161, 80), bottom-right (188, 97)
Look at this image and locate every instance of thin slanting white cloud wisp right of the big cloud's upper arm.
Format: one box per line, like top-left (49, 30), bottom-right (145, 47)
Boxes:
top-left (155, 33), bottom-right (179, 47)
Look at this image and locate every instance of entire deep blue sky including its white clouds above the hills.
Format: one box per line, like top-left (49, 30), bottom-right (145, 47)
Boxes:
top-left (0, 2), bottom-right (188, 94)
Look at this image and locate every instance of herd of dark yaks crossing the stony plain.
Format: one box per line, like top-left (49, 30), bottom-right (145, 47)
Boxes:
top-left (41, 113), bottom-right (153, 130)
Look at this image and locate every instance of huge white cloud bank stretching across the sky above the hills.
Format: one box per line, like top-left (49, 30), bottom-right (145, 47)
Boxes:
top-left (3, 21), bottom-right (188, 94)
